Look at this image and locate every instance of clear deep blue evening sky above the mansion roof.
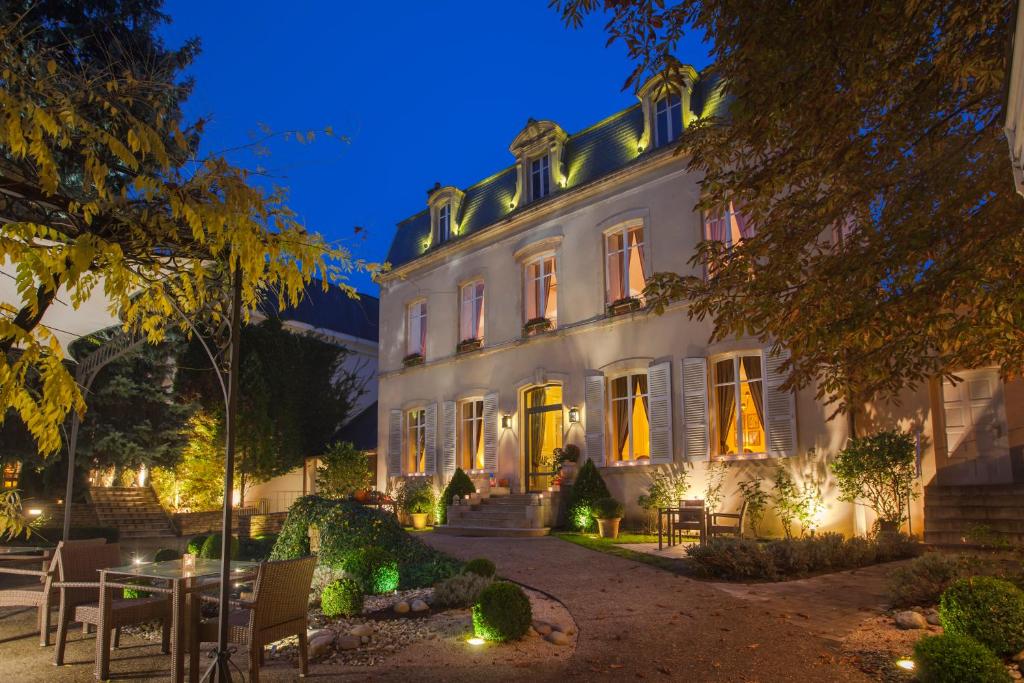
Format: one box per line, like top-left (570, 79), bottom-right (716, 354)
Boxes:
top-left (157, 0), bottom-right (708, 294)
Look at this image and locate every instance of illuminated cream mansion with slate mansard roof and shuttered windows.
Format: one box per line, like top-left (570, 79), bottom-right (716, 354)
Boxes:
top-left (378, 70), bottom-right (1024, 533)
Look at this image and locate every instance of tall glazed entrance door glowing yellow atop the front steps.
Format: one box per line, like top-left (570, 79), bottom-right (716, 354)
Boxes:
top-left (523, 384), bottom-right (563, 492)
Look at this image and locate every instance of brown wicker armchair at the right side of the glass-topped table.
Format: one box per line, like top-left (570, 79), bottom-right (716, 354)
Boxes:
top-left (188, 557), bottom-right (316, 683)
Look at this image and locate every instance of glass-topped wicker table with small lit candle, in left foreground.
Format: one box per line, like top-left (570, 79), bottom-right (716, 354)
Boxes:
top-left (96, 558), bottom-right (259, 683)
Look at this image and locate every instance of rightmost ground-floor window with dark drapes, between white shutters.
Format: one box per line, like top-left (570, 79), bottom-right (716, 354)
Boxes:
top-left (712, 353), bottom-right (767, 456)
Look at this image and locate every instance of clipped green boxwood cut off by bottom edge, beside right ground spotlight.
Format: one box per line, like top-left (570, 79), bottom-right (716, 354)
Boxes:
top-left (913, 633), bottom-right (1011, 683)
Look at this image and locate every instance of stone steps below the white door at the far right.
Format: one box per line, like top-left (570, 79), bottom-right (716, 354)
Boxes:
top-left (925, 483), bottom-right (1024, 546)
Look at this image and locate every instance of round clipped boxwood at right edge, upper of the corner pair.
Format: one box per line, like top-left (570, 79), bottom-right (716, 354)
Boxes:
top-left (939, 577), bottom-right (1024, 656)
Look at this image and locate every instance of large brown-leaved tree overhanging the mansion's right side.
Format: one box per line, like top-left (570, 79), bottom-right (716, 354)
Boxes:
top-left (555, 0), bottom-right (1024, 419)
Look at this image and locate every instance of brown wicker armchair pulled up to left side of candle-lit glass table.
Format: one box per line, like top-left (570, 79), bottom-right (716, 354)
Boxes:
top-left (54, 543), bottom-right (171, 671)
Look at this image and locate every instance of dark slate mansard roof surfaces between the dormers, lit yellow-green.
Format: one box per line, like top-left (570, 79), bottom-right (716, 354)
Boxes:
top-left (387, 71), bottom-right (728, 267)
